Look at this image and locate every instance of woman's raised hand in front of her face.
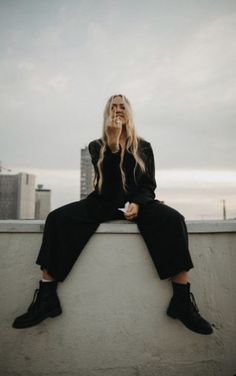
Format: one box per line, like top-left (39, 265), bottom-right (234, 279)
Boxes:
top-left (105, 110), bottom-right (122, 153)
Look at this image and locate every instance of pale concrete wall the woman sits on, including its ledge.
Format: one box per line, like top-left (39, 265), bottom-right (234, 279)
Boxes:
top-left (0, 221), bottom-right (236, 376)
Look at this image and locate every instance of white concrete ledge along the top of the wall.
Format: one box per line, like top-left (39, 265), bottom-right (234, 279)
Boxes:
top-left (0, 219), bottom-right (236, 234)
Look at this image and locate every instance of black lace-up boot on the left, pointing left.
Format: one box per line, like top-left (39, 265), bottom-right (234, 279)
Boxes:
top-left (12, 281), bottom-right (62, 329)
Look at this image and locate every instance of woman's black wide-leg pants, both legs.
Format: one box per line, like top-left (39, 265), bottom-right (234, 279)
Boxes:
top-left (36, 197), bottom-right (193, 281)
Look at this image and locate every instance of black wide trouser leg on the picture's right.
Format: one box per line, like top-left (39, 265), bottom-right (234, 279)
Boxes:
top-left (136, 200), bottom-right (193, 279)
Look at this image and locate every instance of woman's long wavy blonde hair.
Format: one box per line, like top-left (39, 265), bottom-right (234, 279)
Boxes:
top-left (94, 94), bottom-right (146, 193)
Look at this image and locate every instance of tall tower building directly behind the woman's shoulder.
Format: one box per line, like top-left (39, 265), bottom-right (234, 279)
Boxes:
top-left (80, 146), bottom-right (94, 200)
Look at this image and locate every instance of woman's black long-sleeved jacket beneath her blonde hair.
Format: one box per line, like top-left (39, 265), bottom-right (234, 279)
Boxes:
top-left (88, 138), bottom-right (156, 205)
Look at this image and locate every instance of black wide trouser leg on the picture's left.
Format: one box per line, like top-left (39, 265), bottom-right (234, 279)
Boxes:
top-left (36, 199), bottom-right (121, 281)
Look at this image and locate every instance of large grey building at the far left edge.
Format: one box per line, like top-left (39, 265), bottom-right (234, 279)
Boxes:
top-left (0, 172), bottom-right (35, 219)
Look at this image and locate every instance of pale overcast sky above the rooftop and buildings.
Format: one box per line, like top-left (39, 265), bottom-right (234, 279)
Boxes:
top-left (0, 0), bottom-right (236, 219)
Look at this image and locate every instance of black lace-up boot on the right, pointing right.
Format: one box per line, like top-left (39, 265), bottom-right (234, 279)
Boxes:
top-left (166, 282), bottom-right (213, 334)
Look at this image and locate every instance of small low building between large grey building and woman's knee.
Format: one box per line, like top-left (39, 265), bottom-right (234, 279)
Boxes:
top-left (35, 184), bottom-right (51, 219)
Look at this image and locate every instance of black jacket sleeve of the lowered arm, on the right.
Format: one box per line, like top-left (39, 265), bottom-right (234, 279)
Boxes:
top-left (131, 142), bottom-right (157, 205)
